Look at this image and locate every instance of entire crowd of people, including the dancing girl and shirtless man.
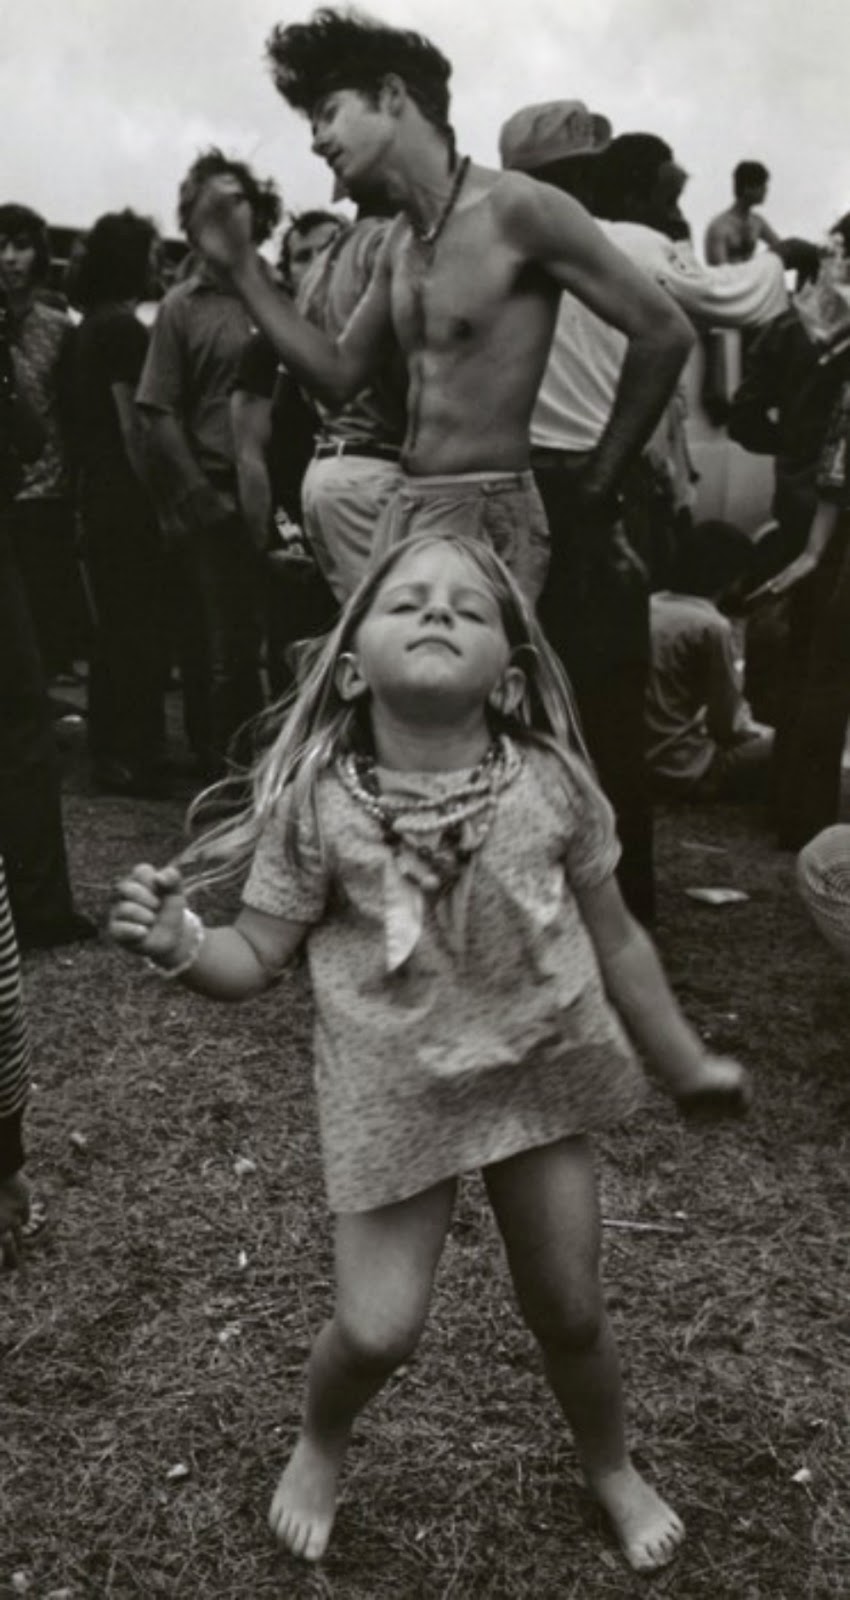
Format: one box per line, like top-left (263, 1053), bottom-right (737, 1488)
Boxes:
top-left (0, 0), bottom-right (850, 1570)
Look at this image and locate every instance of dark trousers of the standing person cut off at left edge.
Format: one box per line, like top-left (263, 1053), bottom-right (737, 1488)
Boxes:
top-left (0, 515), bottom-right (74, 942)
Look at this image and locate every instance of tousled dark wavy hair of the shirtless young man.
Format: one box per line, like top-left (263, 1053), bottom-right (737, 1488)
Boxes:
top-left (266, 6), bottom-right (455, 155)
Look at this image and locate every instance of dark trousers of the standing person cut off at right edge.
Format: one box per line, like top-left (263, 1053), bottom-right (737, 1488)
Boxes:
top-left (773, 515), bottom-right (850, 850)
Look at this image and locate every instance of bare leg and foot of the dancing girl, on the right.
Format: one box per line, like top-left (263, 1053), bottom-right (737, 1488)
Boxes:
top-left (483, 1139), bottom-right (685, 1571)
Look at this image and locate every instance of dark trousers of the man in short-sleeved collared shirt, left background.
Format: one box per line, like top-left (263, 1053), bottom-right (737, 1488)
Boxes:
top-left (174, 515), bottom-right (264, 778)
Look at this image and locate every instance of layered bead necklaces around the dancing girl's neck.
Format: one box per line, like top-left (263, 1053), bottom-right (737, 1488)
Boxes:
top-left (338, 739), bottom-right (522, 894)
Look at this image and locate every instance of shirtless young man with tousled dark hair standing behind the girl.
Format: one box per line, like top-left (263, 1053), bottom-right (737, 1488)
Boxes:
top-left (194, 11), bottom-right (693, 598)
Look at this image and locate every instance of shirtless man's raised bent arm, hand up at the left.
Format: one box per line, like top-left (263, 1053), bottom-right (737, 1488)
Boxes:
top-left (190, 178), bottom-right (392, 406)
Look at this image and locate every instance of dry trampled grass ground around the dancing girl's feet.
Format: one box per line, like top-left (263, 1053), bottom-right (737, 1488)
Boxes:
top-left (0, 732), bottom-right (850, 1600)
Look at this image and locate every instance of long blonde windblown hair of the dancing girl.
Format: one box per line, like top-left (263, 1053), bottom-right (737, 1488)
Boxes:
top-left (178, 533), bottom-right (591, 886)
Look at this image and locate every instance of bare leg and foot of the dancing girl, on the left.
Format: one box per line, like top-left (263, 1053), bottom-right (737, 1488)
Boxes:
top-left (269, 1179), bottom-right (455, 1562)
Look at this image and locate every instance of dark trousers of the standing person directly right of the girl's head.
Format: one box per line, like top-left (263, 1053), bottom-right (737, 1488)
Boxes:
top-left (533, 456), bottom-right (655, 923)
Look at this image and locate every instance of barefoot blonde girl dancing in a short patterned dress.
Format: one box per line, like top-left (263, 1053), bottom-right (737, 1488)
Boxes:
top-left (109, 533), bottom-right (749, 1571)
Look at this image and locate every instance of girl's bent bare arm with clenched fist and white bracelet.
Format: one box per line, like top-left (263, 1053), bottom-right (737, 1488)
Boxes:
top-left (109, 864), bottom-right (306, 1000)
